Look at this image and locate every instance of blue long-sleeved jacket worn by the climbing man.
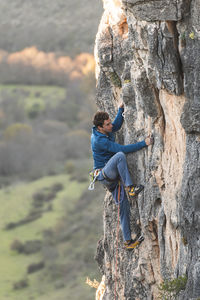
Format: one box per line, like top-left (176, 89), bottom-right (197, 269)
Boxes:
top-left (91, 108), bottom-right (147, 169)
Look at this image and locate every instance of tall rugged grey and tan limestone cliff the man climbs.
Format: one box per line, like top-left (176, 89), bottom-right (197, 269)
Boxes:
top-left (95, 0), bottom-right (200, 300)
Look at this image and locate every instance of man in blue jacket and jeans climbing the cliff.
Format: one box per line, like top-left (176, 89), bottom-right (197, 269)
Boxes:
top-left (89, 104), bottom-right (153, 249)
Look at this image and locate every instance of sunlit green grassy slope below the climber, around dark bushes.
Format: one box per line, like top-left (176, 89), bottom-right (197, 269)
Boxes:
top-left (0, 175), bottom-right (101, 300)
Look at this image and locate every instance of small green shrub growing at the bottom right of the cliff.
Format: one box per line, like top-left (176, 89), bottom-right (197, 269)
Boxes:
top-left (159, 275), bottom-right (187, 300)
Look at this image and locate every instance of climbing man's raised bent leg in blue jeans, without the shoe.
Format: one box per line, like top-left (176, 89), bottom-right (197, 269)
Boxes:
top-left (103, 152), bottom-right (133, 186)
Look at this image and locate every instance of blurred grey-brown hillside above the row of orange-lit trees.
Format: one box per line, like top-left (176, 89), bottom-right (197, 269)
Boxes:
top-left (0, 0), bottom-right (102, 57)
